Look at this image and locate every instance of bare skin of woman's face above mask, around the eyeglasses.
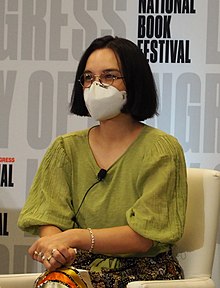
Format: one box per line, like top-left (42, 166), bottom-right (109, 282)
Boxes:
top-left (84, 48), bottom-right (126, 91)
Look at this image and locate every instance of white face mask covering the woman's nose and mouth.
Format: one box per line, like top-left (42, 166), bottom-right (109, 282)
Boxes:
top-left (84, 81), bottom-right (127, 121)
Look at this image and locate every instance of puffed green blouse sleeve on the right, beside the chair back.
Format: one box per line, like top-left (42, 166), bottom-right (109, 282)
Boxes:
top-left (126, 135), bottom-right (187, 244)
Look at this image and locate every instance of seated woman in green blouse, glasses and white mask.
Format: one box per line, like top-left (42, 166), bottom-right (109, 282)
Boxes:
top-left (18, 36), bottom-right (187, 287)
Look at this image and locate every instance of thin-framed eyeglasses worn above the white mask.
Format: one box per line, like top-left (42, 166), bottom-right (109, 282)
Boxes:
top-left (78, 70), bottom-right (124, 88)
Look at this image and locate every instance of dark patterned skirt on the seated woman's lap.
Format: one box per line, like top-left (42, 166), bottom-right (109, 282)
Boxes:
top-left (73, 250), bottom-right (183, 288)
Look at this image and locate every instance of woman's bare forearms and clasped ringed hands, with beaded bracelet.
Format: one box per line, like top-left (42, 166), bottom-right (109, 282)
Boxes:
top-left (29, 225), bottom-right (153, 270)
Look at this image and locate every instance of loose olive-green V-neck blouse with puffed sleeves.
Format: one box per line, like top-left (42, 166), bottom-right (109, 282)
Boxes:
top-left (18, 125), bottom-right (187, 256)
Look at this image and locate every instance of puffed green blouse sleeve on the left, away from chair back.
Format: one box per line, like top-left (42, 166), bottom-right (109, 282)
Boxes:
top-left (18, 137), bottom-right (73, 234)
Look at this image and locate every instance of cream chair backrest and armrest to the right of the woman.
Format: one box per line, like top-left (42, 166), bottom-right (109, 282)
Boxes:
top-left (127, 168), bottom-right (220, 288)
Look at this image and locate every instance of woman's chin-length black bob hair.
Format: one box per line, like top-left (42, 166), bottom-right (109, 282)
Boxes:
top-left (70, 36), bottom-right (158, 121)
